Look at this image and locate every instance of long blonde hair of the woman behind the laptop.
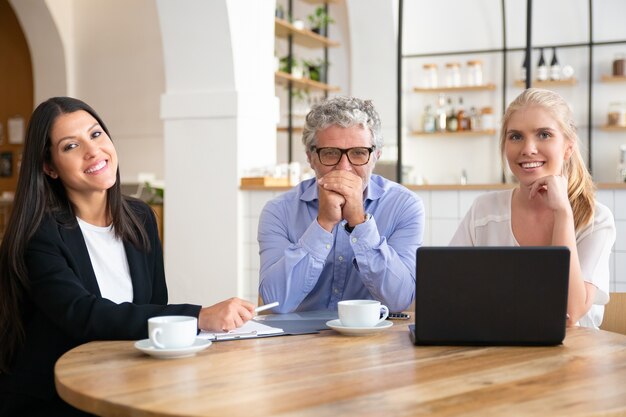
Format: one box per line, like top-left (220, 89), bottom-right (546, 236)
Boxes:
top-left (500, 88), bottom-right (595, 230)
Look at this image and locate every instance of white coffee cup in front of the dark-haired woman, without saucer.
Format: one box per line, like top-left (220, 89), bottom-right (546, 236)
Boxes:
top-left (148, 316), bottom-right (198, 349)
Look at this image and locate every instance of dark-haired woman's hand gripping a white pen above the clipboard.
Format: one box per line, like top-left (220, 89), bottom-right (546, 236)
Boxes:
top-left (198, 297), bottom-right (254, 331)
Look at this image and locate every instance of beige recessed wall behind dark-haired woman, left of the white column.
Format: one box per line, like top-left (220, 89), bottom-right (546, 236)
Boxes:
top-left (73, 0), bottom-right (165, 181)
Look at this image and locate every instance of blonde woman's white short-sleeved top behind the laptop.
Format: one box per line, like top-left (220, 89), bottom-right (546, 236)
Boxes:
top-left (450, 190), bottom-right (615, 328)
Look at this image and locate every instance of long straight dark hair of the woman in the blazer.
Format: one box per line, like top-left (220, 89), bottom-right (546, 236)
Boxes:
top-left (0, 97), bottom-right (150, 372)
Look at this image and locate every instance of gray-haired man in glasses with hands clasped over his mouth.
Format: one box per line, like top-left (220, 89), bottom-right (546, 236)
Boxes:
top-left (258, 97), bottom-right (424, 313)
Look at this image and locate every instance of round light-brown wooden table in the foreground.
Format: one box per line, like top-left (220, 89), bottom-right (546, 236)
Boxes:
top-left (55, 321), bottom-right (626, 417)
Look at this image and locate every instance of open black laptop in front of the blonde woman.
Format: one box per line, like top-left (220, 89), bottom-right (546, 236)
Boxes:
top-left (409, 246), bottom-right (570, 345)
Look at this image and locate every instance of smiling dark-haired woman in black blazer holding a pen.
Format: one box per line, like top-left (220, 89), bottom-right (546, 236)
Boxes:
top-left (0, 97), bottom-right (254, 416)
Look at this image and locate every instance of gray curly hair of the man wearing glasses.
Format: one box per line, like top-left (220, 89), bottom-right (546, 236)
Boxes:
top-left (302, 96), bottom-right (383, 152)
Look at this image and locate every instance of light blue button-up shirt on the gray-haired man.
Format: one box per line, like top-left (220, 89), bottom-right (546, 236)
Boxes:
top-left (258, 175), bottom-right (424, 313)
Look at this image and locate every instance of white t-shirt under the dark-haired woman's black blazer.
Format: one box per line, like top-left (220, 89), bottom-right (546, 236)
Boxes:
top-left (76, 217), bottom-right (133, 304)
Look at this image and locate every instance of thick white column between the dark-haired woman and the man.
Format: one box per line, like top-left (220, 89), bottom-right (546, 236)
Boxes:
top-left (157, 0), bottom-right (277, 305)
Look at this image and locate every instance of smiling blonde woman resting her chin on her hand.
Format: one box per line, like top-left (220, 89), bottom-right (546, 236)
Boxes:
top-left (450, 88), bottom-right (615, 327)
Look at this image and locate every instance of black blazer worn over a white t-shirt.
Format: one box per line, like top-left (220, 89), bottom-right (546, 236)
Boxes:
top-left (0, 200), bottom-right (201, 401)
